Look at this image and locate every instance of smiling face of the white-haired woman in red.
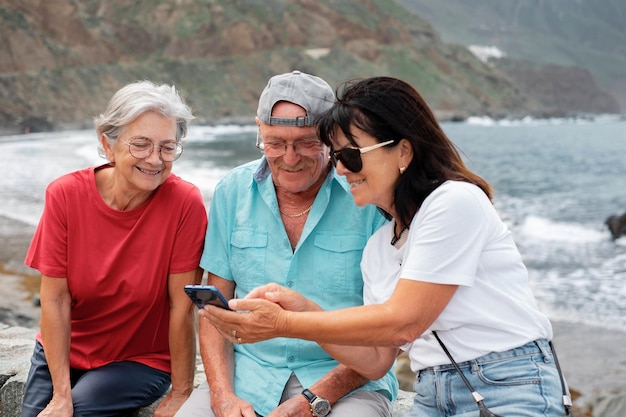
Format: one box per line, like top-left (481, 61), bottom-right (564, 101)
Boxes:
top-left (102, 112), bottom-right (176, 195)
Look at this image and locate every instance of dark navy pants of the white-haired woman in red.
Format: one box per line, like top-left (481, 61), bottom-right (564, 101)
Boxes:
top-left (22, 342), bottom-right (170, 417)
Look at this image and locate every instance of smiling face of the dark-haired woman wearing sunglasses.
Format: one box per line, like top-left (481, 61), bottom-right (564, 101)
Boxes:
top-left (333, 125), bottom-right (412, 217)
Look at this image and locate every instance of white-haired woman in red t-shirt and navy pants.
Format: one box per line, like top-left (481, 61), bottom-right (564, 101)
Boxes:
top-left (22, 81), bottom-right (207, 417)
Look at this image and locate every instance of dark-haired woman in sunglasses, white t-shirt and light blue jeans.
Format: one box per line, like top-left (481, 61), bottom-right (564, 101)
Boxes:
top-left (202, 77), bottom-right (565, 417)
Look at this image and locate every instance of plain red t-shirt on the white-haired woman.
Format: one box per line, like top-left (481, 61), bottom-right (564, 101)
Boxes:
top-left (25, 164), bottom-right (207, 372)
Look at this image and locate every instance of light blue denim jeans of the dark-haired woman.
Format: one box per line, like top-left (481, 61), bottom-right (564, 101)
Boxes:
top-left (405, 340), bottom-right (565, 417)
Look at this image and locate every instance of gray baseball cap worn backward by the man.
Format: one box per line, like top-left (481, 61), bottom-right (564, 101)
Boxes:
top-left (256, 71), bottom-right (335, 127)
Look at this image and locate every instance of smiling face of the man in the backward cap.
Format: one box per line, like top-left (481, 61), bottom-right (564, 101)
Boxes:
top-left (257, 102), bottom-right (329, 193)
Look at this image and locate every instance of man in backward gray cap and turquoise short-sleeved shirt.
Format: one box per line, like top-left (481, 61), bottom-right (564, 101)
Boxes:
top-left (176, 71), bottom-right (398, 417)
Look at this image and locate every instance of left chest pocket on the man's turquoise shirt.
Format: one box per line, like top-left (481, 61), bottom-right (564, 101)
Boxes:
top-left (230, 229), bottom-right (268, 290)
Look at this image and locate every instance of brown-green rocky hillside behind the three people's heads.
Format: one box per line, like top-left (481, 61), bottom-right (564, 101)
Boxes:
top-left (0, 0), bottom-right (616, 130)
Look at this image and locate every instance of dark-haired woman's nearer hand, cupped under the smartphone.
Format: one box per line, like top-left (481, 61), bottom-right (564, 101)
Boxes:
top-left (199, 298), bottom-right (292, 344)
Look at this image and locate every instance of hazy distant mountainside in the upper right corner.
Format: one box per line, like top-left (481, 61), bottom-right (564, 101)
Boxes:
top-left (395, 0), bottom-right (626, 112)
